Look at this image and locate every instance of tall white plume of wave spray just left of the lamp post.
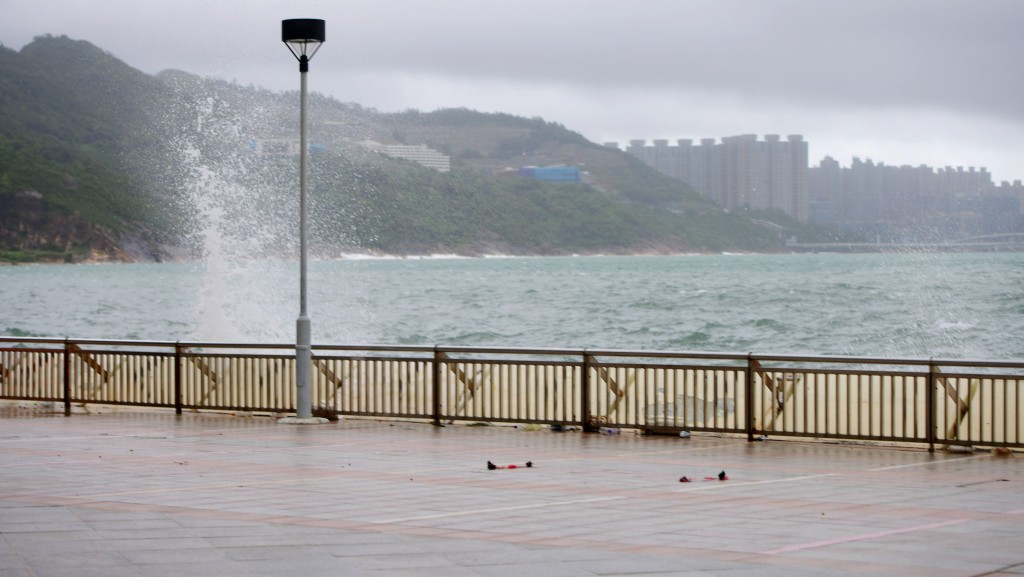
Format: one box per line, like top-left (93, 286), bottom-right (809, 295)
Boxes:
top-left (159, 78), bottom-right (297, 342)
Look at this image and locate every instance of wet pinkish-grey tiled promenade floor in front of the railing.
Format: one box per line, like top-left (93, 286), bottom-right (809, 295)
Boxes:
top-left (0, 406), bottom-right (1024, 577)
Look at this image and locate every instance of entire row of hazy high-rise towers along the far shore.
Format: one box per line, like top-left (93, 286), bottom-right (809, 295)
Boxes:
top-left (618, 134), bottom-right (1024, 242)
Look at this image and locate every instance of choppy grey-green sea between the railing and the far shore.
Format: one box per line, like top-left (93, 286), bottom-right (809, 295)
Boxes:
top-left (0, 253), bottom-right (1024, 360)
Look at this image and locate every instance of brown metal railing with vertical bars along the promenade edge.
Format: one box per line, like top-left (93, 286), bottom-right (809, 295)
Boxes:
top-left (0, 337), bottom-right (1024, 449)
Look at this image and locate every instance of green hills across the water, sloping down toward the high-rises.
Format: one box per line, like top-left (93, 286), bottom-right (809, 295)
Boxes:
top-left (0, 36), bottom-right (830, 262)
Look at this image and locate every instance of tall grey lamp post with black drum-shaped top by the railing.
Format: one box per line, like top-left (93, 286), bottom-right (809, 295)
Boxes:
top-left (281, 18), bottom-right (325, 422)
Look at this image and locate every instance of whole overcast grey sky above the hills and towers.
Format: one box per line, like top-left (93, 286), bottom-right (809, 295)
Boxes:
top-left (0, 0), bottom-right (1024, 181)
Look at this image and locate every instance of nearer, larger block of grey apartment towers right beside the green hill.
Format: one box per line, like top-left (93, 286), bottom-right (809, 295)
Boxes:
top-left (626, 134), bottom-right (808, 220)
